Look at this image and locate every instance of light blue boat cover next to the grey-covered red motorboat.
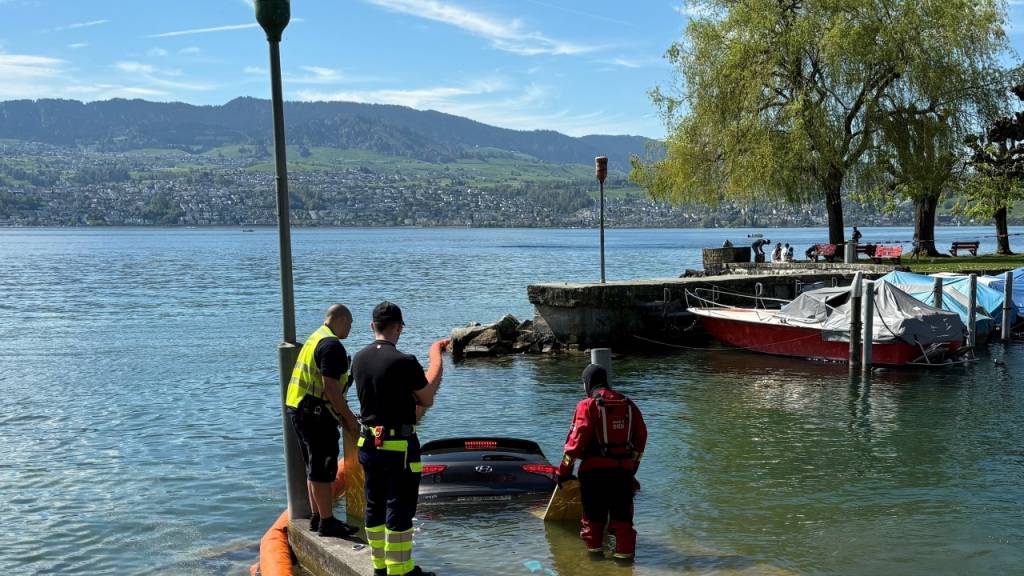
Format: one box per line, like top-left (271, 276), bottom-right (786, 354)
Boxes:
top-left (879, 272), bottom-right (1002, 336)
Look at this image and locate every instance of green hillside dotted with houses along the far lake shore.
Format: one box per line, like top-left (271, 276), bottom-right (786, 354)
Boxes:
top-left (0, 141), bottom-right (959, 228)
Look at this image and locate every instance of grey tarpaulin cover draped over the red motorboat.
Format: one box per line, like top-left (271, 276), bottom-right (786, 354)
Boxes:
top-left (778, 282), bottom-right (967, 345)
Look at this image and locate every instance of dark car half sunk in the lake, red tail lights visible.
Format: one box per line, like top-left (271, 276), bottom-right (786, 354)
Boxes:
top-left (420, 438), bottom-right (558, 502)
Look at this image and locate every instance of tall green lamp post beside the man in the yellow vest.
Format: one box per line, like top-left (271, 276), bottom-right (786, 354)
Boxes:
top-left (255, 0), bottom-right (311, 520)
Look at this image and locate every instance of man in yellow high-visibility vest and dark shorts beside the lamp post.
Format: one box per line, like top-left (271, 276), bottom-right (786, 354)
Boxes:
top-left (285, 304), bottom-right (358, 537)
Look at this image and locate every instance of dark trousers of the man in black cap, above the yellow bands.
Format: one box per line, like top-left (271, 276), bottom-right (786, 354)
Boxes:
top-left (359, 435), bottom-right (420, 532)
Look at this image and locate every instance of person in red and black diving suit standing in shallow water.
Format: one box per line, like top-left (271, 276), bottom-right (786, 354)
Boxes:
top-left (558, 364), bottom-right (647, 561)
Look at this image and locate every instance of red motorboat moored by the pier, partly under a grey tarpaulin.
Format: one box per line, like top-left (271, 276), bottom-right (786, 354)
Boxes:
top-left (687, 282), bottom-right (966, 366)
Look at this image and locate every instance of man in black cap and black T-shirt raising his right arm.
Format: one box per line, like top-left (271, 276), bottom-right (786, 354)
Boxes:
top-left (352, 301), bottom-right (449, 576)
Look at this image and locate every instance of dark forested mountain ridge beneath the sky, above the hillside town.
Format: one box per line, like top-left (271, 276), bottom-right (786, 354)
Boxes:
top-left (0, 97), bottom-right (657, 170)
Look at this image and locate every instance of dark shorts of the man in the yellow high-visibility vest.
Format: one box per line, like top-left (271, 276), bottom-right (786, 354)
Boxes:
top-left (288, 397), bottom-right (341, 482)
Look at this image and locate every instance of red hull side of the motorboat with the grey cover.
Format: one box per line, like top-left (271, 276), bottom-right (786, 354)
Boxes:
top-left (700, 316), bottom-right (956, 366)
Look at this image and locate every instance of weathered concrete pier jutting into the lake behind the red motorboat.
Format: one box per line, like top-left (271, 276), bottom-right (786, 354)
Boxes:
top-left (527, 263), bottom-right (893, 349)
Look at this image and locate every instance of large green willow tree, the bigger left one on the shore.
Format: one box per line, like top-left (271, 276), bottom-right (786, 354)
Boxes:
top-left (631, 0), bottom-right (1006, 243)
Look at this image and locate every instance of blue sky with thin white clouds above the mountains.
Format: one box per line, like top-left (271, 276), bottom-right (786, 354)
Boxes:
top-left (0, 0), bottom-right (1024, 137)
